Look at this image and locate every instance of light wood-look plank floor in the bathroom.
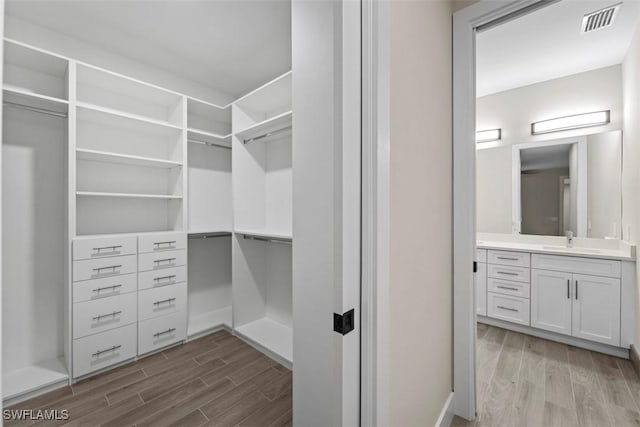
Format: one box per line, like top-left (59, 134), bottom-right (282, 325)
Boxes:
top-left (452, 324), bottom-right (640, 427)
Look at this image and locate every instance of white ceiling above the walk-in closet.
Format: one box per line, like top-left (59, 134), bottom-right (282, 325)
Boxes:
top-left (6, 0), bottom-right (291, 98)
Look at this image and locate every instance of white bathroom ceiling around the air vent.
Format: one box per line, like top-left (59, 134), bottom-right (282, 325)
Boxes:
top-left (476, 0), bottom-right (640, 97)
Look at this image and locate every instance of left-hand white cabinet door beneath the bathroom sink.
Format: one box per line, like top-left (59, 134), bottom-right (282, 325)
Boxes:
top-left (531, 269), bottom-right (572, 335)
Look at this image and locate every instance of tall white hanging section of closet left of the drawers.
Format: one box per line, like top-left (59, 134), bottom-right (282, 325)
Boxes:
top-left (2, 40), bottom-right (69, 399)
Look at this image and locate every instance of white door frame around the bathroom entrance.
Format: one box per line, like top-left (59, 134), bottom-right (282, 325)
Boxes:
top-left (453, 0), bottom-right (557, 420)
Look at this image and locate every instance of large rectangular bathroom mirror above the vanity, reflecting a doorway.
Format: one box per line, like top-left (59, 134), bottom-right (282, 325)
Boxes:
top-left (476, 131), bottom-right (622, 239)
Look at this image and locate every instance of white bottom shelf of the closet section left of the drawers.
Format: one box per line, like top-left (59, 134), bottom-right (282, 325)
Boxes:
top-left (2, 358), bottom-right (69, 400)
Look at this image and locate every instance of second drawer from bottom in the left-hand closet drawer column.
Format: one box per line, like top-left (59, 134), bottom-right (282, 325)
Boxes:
top-left (73, 294), bottom-right (138, 338)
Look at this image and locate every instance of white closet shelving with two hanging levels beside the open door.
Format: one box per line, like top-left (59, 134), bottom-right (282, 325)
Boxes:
top-left (232, 73), bottom-right (293, 366)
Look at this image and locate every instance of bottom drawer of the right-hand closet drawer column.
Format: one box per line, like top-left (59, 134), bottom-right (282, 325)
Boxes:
top-left (138, 311), bottom-right (187, 354)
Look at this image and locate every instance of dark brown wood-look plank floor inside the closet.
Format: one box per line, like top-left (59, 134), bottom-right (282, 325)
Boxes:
top-left (5, 331), bottom-right (292, 427)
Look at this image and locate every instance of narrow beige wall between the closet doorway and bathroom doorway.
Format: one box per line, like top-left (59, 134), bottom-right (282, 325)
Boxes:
top-left (389, 1), bottom-right (453, 427)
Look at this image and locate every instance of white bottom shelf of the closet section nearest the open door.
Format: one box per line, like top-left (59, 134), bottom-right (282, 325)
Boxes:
top-left (235, 317), bottom-right (293, 368)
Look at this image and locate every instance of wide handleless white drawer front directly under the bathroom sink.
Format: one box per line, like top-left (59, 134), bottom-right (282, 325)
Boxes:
top-left (531, 254), bottom-right (620, 277)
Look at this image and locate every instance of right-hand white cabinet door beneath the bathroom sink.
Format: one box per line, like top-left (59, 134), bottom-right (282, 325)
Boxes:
top-left (572, 274), bottom-right (620, 346)
